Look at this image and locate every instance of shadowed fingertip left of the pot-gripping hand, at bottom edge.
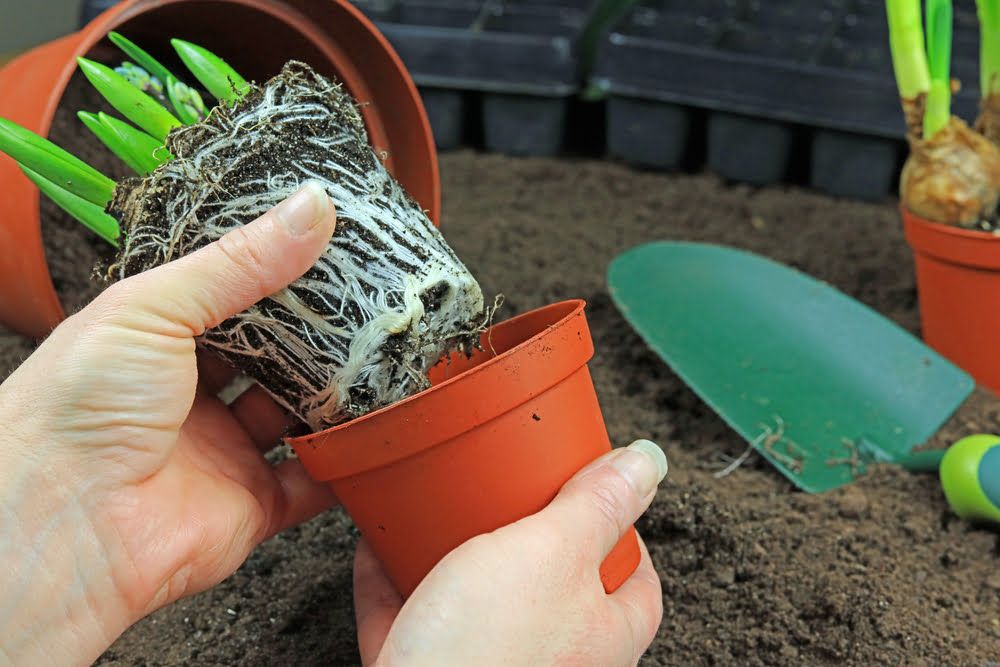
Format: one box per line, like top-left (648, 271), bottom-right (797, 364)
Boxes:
top-left (354, 539), bottom-right (403, 665)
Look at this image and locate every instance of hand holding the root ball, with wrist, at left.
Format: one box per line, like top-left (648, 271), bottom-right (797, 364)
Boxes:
top-left (0, 185), bottom-right (335, 664)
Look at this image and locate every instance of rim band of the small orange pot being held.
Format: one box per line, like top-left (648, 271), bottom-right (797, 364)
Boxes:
top-left (285, 299), bottom-right (594, 482)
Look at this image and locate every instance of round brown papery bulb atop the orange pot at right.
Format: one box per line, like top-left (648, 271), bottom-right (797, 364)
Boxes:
top-left (900, 117), bottom-right (1000, 226)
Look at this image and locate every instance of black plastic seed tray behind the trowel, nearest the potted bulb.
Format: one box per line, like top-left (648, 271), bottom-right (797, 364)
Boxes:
top-left (592, 0), bottom-right (978, 198)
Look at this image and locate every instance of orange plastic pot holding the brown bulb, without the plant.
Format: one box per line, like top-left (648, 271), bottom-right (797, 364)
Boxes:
top-left (901, 207), bottom-right (1000, 392)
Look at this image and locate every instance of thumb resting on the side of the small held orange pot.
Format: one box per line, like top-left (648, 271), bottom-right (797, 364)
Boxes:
top-left (535, 440), bottom-right (667, 562)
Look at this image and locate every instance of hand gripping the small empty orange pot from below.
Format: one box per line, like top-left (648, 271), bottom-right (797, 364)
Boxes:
top-left (354, 441), bottom-right (667, 667)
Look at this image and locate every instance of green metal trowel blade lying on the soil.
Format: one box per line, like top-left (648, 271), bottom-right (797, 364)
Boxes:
top-left (608, 242), bottom-right (975, 493)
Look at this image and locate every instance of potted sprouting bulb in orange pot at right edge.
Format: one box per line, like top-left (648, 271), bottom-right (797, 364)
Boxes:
top-left (886, 0), bottom-right (1000, 390)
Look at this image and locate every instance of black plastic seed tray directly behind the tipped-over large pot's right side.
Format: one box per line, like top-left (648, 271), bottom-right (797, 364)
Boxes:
top-left (357, 0), bottom-right (599, 155)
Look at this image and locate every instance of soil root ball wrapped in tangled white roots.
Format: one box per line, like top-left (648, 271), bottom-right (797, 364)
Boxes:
top-left (110, 62), bottom-right (486, 430)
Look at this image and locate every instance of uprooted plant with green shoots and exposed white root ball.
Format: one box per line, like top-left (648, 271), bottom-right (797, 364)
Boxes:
top-left (0, 33), bottom-right (488, 431)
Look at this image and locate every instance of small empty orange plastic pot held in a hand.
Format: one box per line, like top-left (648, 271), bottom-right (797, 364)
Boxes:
top-left (289, 301), bottom-right (639, 596)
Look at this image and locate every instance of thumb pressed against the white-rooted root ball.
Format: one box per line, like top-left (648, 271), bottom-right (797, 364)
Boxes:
top-left (103, 181), bottom-right (336, 337)
